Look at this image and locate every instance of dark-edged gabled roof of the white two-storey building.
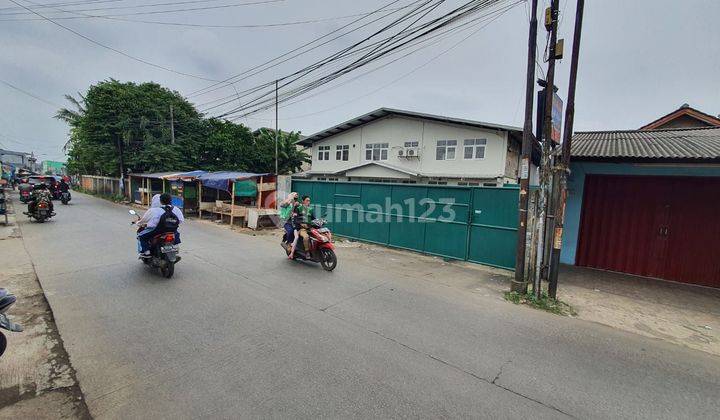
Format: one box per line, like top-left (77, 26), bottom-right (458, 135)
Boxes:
top-left (298, 108), bottom-right (522, 146)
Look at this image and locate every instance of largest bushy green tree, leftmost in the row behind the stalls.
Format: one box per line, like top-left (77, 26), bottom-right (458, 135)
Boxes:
top-left (56, 79), bottom-right (205, 176)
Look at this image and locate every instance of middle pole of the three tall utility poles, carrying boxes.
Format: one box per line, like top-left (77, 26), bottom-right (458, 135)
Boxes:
top-left (533, 0), bottom-right (559, 297)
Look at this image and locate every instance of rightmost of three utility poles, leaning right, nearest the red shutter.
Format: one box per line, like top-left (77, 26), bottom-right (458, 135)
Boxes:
top-left (548, 0), bottom-right (585, 298)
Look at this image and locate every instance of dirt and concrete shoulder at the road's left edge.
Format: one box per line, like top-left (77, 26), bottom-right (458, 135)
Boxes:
top-left (0, 197), bottom-right (91, 419)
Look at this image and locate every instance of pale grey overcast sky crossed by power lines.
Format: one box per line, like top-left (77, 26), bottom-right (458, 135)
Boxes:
top-left (0, 0), bottom-right (720, 160)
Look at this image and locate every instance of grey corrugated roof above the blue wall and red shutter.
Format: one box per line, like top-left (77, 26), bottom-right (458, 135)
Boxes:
top-left (571, 127), bottom-right (720, 161)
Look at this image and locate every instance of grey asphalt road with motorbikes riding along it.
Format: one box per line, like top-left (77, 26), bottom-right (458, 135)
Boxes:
top-left (14, 193), bottom-right (720, 419)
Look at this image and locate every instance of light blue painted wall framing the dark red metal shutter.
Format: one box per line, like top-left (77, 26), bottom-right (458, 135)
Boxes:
top-left (560, 162), bottom-right (720, 264)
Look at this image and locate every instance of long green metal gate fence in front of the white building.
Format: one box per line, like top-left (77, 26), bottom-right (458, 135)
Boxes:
top-left (293, 180), bottom-right (518, 269)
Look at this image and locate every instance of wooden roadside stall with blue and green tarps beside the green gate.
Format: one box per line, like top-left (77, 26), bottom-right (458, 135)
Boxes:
top-left (198, 172), bottom-right (277, 229)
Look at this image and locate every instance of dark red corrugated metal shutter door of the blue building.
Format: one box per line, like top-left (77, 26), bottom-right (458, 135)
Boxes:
top-left (577, 175), bottom-right (720, 287)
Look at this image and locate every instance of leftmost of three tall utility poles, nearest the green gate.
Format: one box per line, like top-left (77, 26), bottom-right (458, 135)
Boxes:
top-left (510, 0), bottom-right (538, 294)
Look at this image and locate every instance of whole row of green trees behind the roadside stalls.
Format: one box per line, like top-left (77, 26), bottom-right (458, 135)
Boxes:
top-left (55, 79), bottom-right (309, 176)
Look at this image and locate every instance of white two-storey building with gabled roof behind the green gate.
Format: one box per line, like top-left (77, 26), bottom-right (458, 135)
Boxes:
top-left (300, 108), bottom-right (536, 186)
